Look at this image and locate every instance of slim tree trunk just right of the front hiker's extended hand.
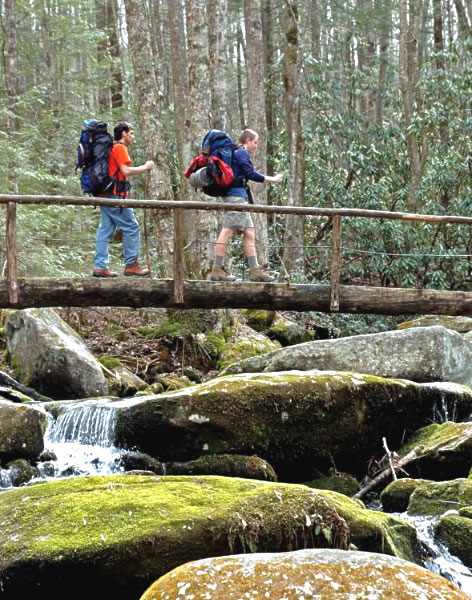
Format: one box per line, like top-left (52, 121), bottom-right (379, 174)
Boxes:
top-left (283, 0), bottom-right (305, 271)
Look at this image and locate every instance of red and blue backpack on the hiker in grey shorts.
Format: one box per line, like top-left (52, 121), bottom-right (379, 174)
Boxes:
top-left (185, 129), bottom-right (247, 196)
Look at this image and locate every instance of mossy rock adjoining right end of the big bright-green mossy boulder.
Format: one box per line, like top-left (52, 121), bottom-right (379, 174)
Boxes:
top-left (317, 490), bottom-right (421, 564)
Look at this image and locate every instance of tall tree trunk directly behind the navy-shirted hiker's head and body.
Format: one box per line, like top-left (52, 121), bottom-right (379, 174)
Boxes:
top-left (244, 0), bottom-right (269, 265)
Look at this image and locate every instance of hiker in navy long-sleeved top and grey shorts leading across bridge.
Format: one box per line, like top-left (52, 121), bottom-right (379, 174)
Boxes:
top-left (210, 129), bottom-right (283, 282)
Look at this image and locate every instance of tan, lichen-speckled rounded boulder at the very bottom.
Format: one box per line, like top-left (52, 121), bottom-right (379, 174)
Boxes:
top-left (141, 549), bottom-right (469, 600)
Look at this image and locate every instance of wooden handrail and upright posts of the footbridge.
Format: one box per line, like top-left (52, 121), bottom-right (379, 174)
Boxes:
top-left (0, 194), bottom-right (472, 311)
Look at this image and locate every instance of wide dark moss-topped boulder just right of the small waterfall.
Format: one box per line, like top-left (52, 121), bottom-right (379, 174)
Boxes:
top-left (114, 371), bottom-right (472, 481)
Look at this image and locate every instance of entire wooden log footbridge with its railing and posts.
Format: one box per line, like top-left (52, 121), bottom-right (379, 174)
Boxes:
top-left (0, 194), bottom-right (472, 316)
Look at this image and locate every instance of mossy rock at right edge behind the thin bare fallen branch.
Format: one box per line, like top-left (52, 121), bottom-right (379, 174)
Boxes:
top-left (398, 420), bottom-right (472, 480)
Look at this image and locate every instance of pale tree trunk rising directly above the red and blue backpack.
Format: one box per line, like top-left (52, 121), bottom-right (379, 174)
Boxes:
top-left (208, 0), bottom-right (228, 129)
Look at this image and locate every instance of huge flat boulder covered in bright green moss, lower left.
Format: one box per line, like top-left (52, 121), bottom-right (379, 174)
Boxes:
top-left (0, 475), bottom-right (349, 600)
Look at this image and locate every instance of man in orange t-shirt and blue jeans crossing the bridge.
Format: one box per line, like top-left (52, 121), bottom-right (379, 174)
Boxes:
top-left (93, 121), bottom-right (154, 277)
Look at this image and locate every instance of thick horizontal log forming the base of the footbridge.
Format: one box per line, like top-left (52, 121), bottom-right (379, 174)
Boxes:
top-left (0, 277), bottom-right (472, 316)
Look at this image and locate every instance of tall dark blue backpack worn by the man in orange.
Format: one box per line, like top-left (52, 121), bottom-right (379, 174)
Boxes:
top-left (75, 119), bottom-right (116, 196)
